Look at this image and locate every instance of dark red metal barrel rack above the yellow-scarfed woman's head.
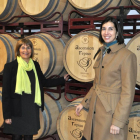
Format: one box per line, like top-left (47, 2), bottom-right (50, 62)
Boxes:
top-left (0, 12), bottom-right (68, 39)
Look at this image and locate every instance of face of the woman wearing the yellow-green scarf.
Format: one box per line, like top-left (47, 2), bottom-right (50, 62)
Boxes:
top-left (19, 44), bottom-right (32, 62)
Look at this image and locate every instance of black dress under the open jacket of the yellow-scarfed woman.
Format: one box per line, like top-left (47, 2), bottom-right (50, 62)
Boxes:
top-left (3, 70), bottom-right (40, 135)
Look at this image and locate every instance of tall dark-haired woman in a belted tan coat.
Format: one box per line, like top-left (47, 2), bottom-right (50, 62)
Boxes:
top-left (76, 17), bottom-right (137, 140)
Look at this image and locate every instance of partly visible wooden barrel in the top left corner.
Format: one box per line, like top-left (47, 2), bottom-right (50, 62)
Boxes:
top-left (0, 0), bottom-right (33, 23)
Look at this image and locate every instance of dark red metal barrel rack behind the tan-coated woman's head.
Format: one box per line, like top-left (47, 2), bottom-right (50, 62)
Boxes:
top-left (68, 6), bottom-right (140, 38)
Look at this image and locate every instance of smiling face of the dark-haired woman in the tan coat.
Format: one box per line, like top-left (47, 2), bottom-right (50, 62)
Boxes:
top-left (101, 21), bottom-right (117, 43)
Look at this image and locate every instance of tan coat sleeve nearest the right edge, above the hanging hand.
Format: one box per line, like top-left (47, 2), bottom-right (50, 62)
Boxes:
top-left (112, 53), bottom-right (137, 128)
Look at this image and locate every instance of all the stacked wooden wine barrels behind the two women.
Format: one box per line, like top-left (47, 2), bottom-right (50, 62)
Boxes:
top-left (0, 0), bottom-right (140, 140)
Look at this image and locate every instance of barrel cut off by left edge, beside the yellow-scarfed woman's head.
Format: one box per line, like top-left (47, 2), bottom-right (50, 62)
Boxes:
top-left (0, 34), bottom-right (17, 74)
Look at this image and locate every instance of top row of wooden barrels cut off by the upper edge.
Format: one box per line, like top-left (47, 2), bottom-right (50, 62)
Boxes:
top-left (0, 0), bottom-right (133, 22)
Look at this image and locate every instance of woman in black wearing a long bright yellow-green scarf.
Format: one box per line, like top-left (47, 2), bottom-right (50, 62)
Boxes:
top-left (2, 39), bottom-right (69, 140)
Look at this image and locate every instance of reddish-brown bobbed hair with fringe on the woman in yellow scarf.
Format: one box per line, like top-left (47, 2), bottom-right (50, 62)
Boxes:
top-left (15, 38), bottom-right (34, 58)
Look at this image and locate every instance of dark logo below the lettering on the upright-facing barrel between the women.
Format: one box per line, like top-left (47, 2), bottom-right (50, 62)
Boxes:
top-left (77, 57), bottom-right (92, 72)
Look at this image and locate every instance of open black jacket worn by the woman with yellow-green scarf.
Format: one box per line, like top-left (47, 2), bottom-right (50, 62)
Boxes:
top-left (2, 60), bottom-right (65, 119)
